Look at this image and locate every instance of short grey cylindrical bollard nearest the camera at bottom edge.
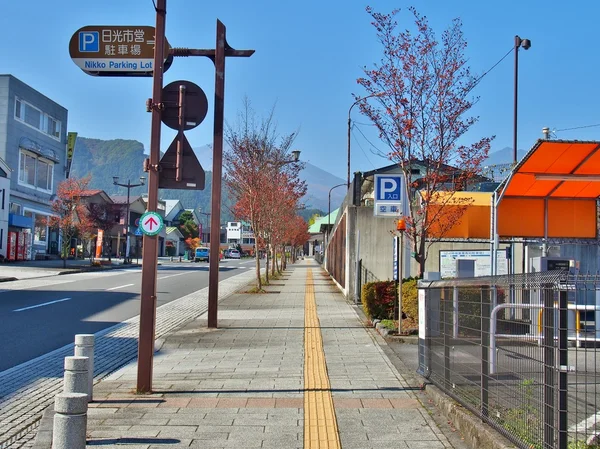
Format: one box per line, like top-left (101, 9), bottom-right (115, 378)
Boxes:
top-left (52, 393), bottom-right (87, 449)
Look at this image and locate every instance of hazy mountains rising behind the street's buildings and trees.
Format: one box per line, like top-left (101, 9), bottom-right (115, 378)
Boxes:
top-left (71, 137), bottom-right (346, 221)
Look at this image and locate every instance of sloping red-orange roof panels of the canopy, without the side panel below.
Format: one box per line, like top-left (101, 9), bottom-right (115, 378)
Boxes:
top-left (499, 140), bottom-right (600, 199)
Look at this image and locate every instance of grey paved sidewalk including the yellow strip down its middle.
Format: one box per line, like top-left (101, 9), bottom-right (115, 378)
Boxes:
top-left (35, 259), bottom-right (466, 449)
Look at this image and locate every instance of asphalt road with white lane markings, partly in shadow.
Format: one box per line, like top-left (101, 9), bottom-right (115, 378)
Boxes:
top-left (0, 259), bottom-right (255, 371)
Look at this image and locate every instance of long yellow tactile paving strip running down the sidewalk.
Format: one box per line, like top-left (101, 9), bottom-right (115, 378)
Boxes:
top-left (304, 269), bottom-right (341, 449)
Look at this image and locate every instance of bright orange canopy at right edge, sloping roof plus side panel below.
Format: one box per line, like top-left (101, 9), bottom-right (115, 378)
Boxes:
top-left (497, 140), bottom-right (600, 238)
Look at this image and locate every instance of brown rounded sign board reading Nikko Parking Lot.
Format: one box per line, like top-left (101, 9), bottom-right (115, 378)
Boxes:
top-left (69, 25), bottom-right (169, 76)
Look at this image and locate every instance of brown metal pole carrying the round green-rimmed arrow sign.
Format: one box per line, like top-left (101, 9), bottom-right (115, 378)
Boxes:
top-left (137, 0), bottom-right (167, 393)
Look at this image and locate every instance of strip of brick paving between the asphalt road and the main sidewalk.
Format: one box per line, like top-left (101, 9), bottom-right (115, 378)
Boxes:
top-left (0, 271), bottom-right (253, 447)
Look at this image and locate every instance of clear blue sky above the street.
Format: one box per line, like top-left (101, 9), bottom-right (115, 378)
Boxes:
top-left (0, 0), bottom-right (600, 179)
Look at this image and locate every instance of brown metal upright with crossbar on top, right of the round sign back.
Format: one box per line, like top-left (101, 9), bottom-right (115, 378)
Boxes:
top-left (208, 20), bottom-right (225, 328)
